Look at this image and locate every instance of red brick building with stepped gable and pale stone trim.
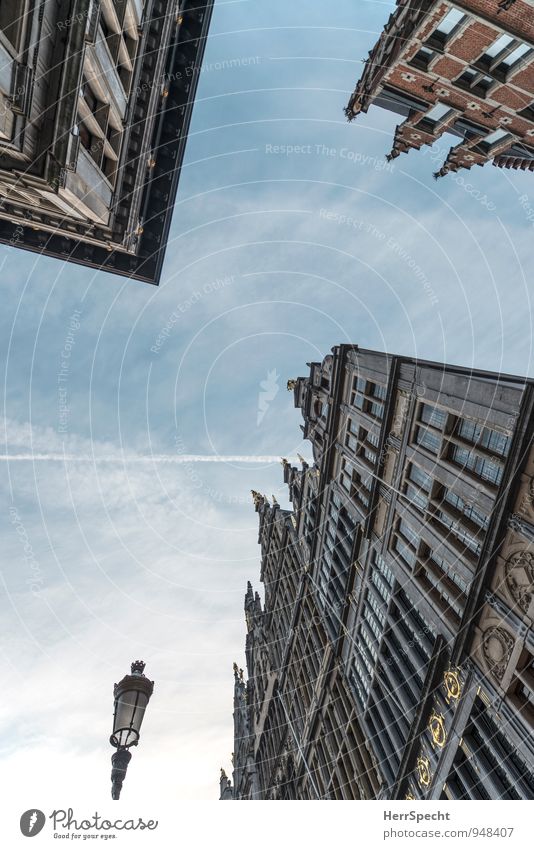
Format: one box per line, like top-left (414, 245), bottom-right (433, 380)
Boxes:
top-left (346, 0), bottom-right (534, 177)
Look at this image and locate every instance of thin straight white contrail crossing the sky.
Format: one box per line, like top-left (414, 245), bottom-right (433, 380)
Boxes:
top-left (0, 454), bottom-right (311, 465)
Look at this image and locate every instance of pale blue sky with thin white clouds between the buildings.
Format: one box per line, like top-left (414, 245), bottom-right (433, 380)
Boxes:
top-left (0, 0), bottom-right (534, 814)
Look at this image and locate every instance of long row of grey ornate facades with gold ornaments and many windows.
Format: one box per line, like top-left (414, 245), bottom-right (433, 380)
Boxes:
top-left (221, 345), bottom-right (534, 800)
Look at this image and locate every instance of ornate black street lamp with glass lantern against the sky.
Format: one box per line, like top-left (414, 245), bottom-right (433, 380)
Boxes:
top-left (109, 660), bottom-right (154, 799)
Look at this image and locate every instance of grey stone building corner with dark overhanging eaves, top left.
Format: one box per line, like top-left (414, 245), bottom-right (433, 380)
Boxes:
top-left (0, 0), bottom-right (213, 283)
